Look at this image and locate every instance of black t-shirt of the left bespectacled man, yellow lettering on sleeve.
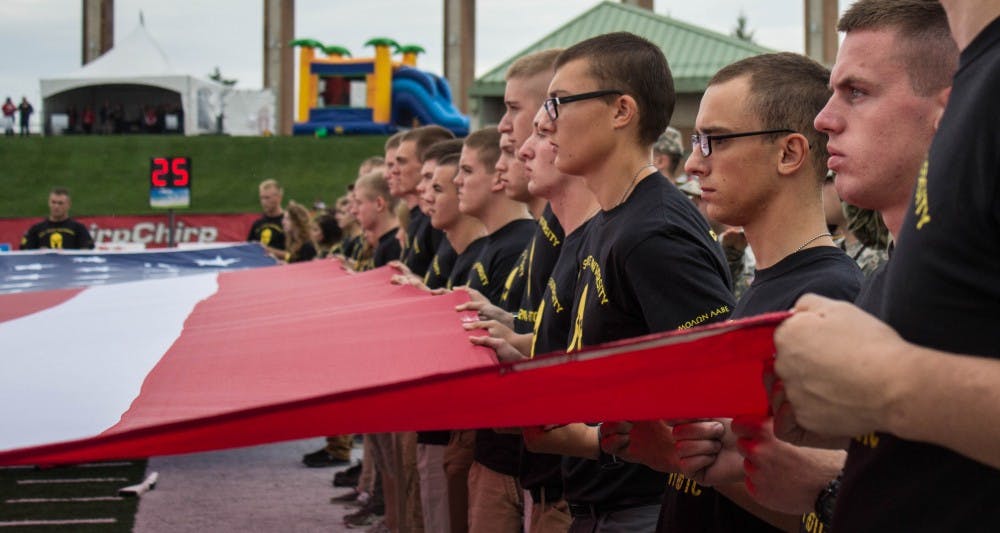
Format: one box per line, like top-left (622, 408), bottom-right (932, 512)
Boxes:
top-left (563, 173), bottom-right (733, 505)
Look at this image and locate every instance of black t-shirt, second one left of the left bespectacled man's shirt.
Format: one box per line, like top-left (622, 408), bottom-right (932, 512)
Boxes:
top-left (504, 204), bottom-right (566, 333)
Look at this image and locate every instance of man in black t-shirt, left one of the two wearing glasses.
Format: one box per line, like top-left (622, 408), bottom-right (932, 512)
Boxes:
top-left (524, 33), bottom-right (732, 530)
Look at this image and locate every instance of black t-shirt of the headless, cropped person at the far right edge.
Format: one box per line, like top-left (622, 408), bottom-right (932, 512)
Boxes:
top-left (834, 19), bottom-right (1000, 532)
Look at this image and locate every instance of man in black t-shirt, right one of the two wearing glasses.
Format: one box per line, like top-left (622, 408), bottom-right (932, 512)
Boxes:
top-left (628, 53), bottom-right (862, 532)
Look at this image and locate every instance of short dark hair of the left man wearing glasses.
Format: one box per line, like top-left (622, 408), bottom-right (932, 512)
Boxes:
top-left (555, 32), bottom-right (677, 146)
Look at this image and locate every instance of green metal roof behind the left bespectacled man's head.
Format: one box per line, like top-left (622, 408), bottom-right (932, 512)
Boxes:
top-left (469, 2), bottom-right (774, 96)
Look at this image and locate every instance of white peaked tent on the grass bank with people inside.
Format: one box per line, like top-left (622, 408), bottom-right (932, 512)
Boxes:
top-left (40, 23), bottom-right (274, 135)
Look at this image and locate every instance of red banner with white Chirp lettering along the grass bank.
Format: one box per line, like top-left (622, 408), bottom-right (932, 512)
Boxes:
top-left (0, 213), bottom-right (260, 250)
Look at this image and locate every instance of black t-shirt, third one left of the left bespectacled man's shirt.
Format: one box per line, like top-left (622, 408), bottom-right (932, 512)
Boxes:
top-left (469, 219), bottom-right (536, 476)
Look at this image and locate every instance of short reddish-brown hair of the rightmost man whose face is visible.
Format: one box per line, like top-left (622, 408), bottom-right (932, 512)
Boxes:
top-left (837, 0), bottom-right (959, 96)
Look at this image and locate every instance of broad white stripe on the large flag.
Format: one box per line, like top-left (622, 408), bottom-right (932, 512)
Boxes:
top-left (0, 274), bottom-right (218, 450)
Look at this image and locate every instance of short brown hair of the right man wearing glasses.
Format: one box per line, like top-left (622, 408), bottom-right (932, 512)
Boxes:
top-left (708, 52), bottom-right (831, 183)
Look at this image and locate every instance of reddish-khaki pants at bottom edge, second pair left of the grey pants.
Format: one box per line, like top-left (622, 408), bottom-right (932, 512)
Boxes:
top-left (469, 462), bottom-right (524, 533)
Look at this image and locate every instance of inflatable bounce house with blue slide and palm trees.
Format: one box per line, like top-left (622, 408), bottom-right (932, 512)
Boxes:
top-left (289, 38), bottom-right (469, 136)
